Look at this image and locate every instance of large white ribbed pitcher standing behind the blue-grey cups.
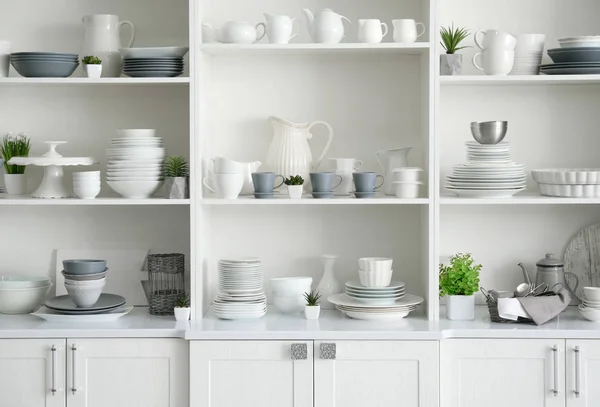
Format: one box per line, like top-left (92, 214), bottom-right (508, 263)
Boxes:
top-left (266, 117), bottom-right (333, 185)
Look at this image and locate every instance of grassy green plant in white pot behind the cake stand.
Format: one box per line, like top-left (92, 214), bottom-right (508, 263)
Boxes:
top-left (0, 133), bottom-right (31, 195)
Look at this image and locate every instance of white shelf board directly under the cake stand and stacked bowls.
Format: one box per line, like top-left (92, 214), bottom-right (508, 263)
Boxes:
top-left (0, 194), bottom-right (190, 206)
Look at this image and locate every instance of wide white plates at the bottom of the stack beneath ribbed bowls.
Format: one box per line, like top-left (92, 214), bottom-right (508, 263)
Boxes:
top-left (328, 294), bottom-right (423, 320)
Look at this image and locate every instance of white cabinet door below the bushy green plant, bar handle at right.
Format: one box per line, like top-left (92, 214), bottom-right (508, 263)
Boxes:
top-left (440, 339), bottom-right (566, 407)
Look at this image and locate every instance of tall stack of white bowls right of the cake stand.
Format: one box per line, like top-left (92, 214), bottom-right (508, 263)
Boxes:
top-left (106, 129), bottom-right (165, 199)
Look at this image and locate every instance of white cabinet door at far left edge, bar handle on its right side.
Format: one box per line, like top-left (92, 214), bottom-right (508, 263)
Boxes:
top-left (0, 339), bottom-right (65, 407)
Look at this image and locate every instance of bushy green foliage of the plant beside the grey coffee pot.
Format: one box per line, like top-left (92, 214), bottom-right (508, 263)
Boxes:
top-left (440, 253), bottom-right (481, 297)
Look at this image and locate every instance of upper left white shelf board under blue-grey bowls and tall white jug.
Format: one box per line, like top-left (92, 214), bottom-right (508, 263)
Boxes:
top-left (0, 77), bottom-right (190, 86)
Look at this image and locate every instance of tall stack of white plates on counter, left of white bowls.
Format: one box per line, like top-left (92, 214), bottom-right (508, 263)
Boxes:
top-left (213, 258), bottom-right (267, 319)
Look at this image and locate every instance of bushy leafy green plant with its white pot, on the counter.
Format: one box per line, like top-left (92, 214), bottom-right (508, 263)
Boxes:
top-left (440, 253), bottom-right (481, 321)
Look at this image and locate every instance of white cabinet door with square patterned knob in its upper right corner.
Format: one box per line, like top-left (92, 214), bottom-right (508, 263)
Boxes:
top-left (190, 341), bottom-right (313, 407)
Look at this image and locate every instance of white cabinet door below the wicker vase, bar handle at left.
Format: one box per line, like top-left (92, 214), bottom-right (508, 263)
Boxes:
top-left (66, 339), bottom-right (189, 407)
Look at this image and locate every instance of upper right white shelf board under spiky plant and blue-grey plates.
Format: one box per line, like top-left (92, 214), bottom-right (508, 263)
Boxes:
top-left (439, 75), bottom-right (600, 86)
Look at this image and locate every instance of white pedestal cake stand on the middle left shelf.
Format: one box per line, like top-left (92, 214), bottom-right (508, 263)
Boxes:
top-left (8, 141), bottom-right (95, 198)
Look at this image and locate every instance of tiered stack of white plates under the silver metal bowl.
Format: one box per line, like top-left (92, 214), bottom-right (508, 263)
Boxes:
top-left (446, 141), bottom-right (527, 198)
